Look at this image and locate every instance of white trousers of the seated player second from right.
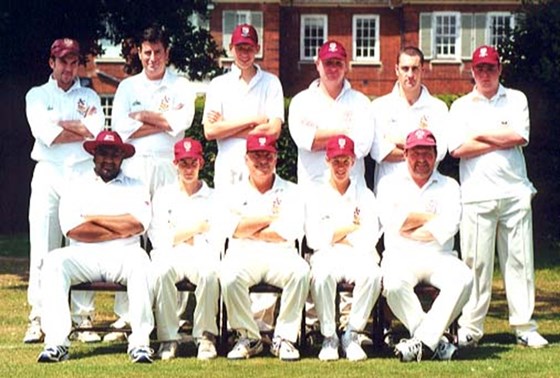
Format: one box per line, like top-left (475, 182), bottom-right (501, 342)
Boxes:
top-left (310, 244), bottom-right (381, 337)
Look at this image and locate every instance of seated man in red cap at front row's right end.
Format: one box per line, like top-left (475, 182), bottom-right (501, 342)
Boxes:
top-left (377, 129), bottom-right (473, 362)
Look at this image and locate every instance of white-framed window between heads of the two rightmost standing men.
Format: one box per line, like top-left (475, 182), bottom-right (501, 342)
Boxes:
top-left (434, 13), bottom-right (459, 59)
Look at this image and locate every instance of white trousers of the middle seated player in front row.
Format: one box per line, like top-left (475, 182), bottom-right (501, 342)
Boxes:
top-left (220, 246), bottom-right (309, 343)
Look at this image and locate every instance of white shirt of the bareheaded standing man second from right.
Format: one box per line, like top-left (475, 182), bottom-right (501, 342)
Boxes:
top-left (370, 83), bottom-right (450, 190)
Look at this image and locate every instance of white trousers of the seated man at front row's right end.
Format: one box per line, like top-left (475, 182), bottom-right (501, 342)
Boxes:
top-left (381, 251), bottom-right (473, 351)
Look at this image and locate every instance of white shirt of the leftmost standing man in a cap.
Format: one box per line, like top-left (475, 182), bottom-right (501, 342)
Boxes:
top-left (25, 76), bottom-right (105, 166)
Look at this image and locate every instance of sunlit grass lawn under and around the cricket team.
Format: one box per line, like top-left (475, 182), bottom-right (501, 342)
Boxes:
top-left (0, 237), bottom-right (560, 378)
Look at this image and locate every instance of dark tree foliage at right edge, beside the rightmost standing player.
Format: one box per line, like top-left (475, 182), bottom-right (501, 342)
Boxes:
top-left (502, 0), bottom-right (560, 138)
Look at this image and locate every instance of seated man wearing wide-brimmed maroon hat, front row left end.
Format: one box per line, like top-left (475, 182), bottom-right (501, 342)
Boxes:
top-left (38, 131), bottom-right (154, 363)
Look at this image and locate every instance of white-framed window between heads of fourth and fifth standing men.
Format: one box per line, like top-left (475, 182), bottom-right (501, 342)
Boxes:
top-left (352, 15), bottom-right (379, 62)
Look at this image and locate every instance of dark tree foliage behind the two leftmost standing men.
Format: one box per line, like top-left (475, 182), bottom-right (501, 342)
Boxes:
top-left (0, 0), bottom-right (221, 82)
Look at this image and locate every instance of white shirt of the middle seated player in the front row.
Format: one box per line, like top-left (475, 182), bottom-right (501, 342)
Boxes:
top-left (220, 175), bottom-right (304, 251)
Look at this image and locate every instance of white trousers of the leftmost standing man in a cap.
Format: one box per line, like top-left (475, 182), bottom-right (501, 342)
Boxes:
top-left (27, 159), bottom-right (93, 320)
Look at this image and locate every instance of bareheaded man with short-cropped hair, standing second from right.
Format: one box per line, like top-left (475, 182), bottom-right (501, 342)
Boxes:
top-left (370, 46), bottom-right (448, 190)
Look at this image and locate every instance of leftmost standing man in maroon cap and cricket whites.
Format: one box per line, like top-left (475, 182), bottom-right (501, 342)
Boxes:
top-left (23, 38), bottom-right (104, 343)
